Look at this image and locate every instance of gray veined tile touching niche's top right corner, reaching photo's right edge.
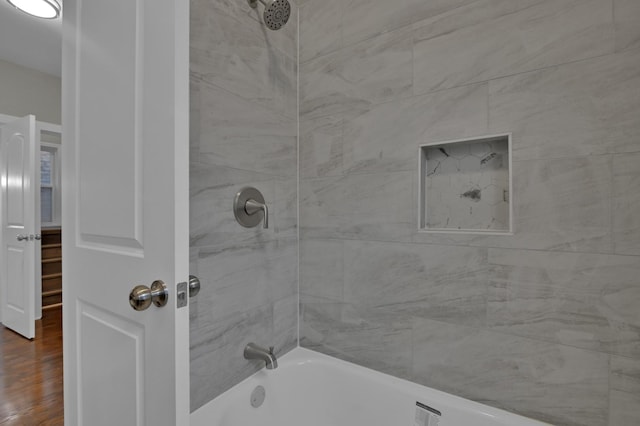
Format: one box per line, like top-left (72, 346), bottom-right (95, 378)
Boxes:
top-left (489, 50), bottom-right (640, 160)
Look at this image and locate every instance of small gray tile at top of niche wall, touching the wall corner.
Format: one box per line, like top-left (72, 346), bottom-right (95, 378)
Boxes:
top-left (300, 0), bottom-right (344, 62)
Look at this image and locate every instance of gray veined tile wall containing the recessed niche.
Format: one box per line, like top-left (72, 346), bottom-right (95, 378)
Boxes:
top-left (300, 0), bottom-right (640, 426)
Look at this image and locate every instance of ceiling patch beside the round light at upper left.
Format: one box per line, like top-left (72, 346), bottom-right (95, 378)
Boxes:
top-left (0, 0), bottom-right (62, 77)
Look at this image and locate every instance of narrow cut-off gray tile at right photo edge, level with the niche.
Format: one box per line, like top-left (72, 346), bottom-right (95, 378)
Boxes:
top-left (612, 153), bottom-right (640, 255)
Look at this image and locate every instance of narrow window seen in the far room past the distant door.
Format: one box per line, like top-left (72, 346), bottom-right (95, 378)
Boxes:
top-left (40, 143), bottom-right (60, 225)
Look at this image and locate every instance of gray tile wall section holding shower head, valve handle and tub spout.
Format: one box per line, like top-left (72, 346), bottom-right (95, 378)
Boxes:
top-left (189, 0), bottom-right (298, 411)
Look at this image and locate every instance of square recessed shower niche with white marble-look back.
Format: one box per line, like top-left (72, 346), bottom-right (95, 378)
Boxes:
top-left (419, 134), bottom-right (513, 235)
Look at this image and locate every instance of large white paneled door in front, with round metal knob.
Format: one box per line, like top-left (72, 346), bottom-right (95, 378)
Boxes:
top-left (62, 0), bottom-right (189, 426)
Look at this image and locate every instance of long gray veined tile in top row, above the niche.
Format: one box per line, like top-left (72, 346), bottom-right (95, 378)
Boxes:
top-left (414, 0), bottom-right (614, 93)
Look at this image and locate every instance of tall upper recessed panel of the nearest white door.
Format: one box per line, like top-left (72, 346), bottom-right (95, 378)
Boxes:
top-left (77, 0), bottom-right (145, 250)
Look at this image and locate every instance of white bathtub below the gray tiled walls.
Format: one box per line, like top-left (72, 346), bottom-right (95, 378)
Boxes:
top-left (191, 348), bottom-right (549, 426)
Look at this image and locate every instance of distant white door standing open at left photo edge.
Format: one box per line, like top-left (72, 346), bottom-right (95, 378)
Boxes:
top-left (0, 115), bottom-right (40, 339)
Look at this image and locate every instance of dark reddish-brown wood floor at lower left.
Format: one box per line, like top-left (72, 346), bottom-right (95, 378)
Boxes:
top-left (0, 308), bottom-right (64, 426)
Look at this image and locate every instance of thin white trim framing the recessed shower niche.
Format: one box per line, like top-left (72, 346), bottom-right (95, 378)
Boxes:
top-left (418, 132), bottom-right (515, 235)
